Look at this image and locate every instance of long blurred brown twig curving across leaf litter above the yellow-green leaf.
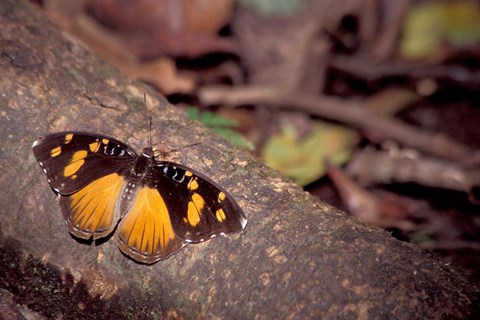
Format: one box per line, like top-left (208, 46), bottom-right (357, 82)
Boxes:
top-left (199, 86), bottom-right (473, 161)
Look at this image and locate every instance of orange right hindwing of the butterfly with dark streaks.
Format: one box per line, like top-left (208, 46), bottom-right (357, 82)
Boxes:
top-left (117, 187), bottom-right (183, 263)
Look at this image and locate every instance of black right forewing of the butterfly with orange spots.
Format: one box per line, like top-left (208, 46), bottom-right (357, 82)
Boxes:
top-left (152, 161), bottom-right (247, 243)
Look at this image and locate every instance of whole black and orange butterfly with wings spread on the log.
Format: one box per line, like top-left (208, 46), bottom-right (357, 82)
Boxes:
top-left (33, 132), bottom-right (247, 264)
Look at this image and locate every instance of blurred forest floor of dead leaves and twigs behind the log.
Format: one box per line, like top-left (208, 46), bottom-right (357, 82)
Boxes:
top-left (33, 0), bottom-right (480, 283)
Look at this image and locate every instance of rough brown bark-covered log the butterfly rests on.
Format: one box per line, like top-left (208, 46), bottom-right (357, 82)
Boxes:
top-left (0, 0), bottom-right (478, 319)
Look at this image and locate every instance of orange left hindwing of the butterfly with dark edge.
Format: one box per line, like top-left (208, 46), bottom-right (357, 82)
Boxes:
top-left (61, 173), bottom-right (125, 239)
